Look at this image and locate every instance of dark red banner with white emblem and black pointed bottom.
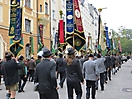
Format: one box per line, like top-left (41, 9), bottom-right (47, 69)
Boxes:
top-left (74, 0), bottom-right (86, 51)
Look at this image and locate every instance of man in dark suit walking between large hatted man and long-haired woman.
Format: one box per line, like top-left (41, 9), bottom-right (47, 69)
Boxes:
top-left (56, 53), bottom-right (66, 88)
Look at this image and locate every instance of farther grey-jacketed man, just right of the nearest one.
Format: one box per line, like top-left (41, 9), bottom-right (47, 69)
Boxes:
top-left (95, 54), bottom-right (106, 91)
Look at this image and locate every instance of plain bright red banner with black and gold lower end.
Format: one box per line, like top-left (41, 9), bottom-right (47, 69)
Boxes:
top-left (57, 20), bottom-right (66, 52)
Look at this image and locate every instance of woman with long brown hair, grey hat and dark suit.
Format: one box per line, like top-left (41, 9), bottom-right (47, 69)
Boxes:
top-left (65, 48), bottom-right (84, 99)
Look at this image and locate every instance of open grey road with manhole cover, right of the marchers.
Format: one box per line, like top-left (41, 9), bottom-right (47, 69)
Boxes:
top-left (97, 60), bottom-right (132, 99)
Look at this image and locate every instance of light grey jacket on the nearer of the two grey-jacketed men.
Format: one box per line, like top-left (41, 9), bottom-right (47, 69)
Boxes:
top-left (83, 60), bottom-right (99, 81)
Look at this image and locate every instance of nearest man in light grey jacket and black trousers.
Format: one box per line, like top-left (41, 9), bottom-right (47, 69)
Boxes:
top-left (83, 54), bottom-right (99, 99)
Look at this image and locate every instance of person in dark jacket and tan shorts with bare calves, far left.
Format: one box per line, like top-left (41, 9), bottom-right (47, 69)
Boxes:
top-left (2, 52), bottom-right (21, 99)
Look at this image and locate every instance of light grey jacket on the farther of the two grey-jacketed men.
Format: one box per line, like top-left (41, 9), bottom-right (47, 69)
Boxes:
top-left (95, 57), bottom-right (106, 73)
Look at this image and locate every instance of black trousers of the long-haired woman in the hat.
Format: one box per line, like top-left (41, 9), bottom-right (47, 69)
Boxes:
top-left (67, 81), bottom-right (82, 99)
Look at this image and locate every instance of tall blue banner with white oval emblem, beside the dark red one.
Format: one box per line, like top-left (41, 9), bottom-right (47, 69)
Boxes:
top-left (66, 0), bottom-right (74, 46)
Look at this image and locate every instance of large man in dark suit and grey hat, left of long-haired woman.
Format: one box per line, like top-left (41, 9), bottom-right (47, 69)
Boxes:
top-left (34, 48), bottom-right (59, 99)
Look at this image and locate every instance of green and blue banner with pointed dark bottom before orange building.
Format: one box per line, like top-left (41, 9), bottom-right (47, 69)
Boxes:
top-left (9, 0), bottom-right (23, 57)
